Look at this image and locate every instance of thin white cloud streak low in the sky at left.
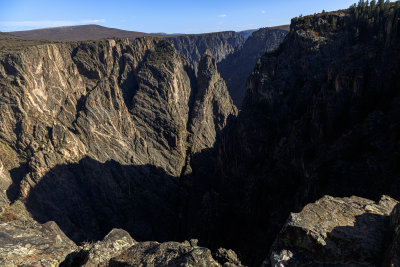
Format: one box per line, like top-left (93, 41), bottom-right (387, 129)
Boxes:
top-left (0, 19), bottom-right (106, 28)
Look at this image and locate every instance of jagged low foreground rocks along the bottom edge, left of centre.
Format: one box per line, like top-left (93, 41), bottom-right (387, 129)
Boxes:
top-left (61, 229), bottom-right (242, 267)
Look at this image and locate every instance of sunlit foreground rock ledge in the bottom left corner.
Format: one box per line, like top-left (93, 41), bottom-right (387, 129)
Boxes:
top-left (0, 220), bottom-right (77, 267)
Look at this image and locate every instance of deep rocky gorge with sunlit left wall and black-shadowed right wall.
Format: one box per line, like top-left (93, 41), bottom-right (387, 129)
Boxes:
top-left (0, 1), bottom-right (400, 266)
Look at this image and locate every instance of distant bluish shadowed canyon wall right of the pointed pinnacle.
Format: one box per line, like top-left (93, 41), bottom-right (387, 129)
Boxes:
top-left (218, 28), bottom-right (289, 108)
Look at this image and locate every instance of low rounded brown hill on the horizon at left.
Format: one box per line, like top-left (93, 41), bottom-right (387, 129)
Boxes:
top-left (9, 25), bottom-right (165, 41)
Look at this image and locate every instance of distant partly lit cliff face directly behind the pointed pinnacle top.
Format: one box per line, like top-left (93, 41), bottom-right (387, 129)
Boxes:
top-left (167, 32), bottom-right (244, 72)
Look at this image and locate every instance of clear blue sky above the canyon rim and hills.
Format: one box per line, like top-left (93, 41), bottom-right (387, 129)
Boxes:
top-left (0, 0), bottom-right (358, 33)
